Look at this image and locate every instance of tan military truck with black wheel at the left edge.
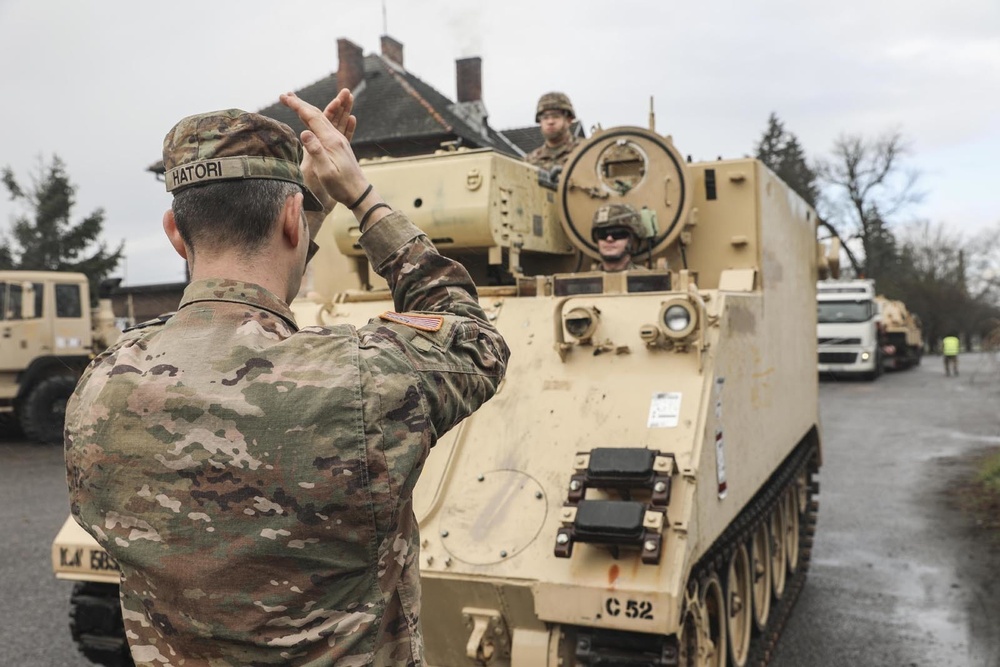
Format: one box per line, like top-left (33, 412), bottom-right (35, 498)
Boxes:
top-left (0, 271), bottom-right (118, 443)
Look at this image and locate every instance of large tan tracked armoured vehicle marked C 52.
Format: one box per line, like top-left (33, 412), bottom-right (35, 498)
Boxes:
top-left (53, 121), bottom-right (821, 667)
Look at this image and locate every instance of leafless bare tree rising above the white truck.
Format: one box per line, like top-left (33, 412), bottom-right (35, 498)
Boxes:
top-left (816, 132), bottom-right (923, 279)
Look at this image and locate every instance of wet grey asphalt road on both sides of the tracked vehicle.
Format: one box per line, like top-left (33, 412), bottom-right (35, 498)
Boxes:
top-left (0, 355), bottom-right (1000, 667)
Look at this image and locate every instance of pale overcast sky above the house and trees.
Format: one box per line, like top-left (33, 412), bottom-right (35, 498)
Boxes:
top-left (0, 0), bottom-right (1000, 285)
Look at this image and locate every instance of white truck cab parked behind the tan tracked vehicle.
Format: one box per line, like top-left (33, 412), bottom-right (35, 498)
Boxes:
top-left (816, 280), bottom-right (882, 380)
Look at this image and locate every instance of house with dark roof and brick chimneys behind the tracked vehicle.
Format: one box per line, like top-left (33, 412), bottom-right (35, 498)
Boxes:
top-left (126, 35), bottom-right (582, 322)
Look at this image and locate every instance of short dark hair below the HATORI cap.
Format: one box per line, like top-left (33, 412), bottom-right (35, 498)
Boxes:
top-left (172, 178), bottom-right (302, 255)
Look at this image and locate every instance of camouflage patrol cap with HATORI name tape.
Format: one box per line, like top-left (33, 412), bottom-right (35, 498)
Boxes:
top-left (163, 109), bottom-right (323, 211)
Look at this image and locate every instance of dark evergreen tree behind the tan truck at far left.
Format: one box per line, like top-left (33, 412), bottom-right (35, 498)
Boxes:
top-left (0, 156), bottom-right (125, 302)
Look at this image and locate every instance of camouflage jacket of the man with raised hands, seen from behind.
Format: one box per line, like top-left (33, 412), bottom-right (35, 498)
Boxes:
top-left (66, 213), bottom-right (509, 667)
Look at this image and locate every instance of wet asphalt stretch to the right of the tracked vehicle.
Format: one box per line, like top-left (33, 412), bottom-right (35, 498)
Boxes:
top-left (771, 355), bottom-right (1000, 667)
